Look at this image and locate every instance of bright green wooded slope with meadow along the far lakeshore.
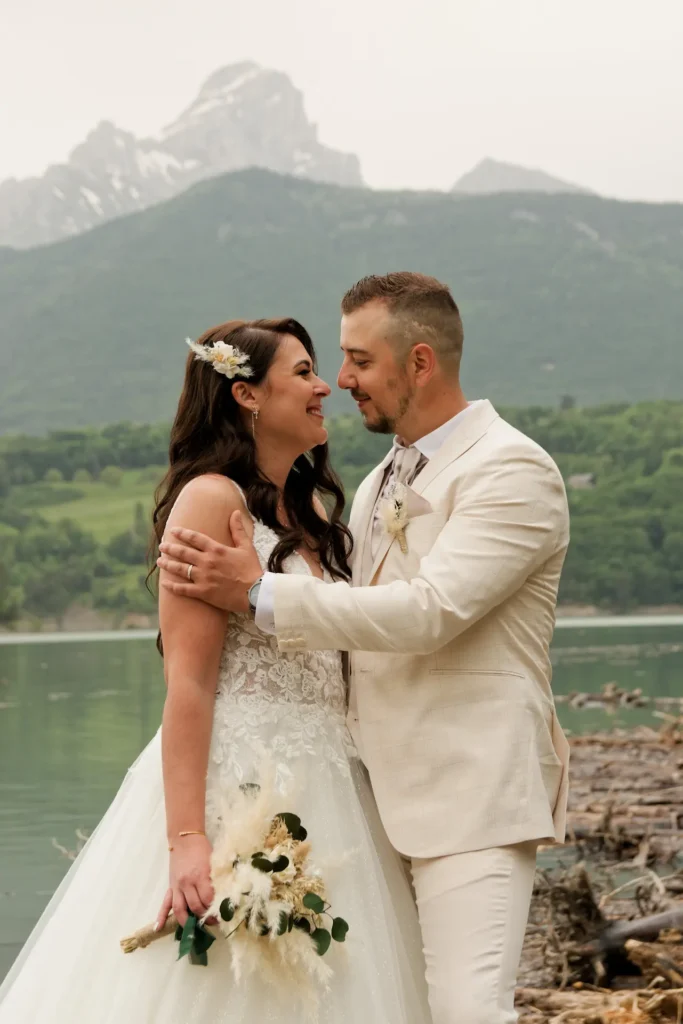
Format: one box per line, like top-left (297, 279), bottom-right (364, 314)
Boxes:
top-left (0, 401), bottom-right (683, 626)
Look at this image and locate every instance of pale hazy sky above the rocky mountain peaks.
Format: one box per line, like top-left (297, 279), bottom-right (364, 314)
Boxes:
top-left (0, 0), bottom-right (683, 201)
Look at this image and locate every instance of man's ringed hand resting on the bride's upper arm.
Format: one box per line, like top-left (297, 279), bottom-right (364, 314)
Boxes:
top-left (157, 512), bottom-right (263, 612)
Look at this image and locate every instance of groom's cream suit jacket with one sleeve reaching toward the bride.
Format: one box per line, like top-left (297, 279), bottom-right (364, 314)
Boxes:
top-left (273, 401), bottom-right (569, 857)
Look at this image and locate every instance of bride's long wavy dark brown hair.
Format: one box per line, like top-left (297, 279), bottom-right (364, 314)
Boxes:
top-left (150, 318), bottom-right (351, 598)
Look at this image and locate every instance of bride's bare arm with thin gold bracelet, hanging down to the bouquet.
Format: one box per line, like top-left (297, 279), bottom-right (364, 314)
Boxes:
top-left (158, 476), bottom-right (243, 924)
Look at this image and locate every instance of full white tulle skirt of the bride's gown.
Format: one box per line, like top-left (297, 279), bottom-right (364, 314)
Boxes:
top-left (0, 726), bottom-right (430, 1024)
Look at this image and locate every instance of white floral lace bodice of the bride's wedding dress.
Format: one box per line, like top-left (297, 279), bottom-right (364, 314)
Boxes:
top-left (209, 522), bottom-right (352, 782)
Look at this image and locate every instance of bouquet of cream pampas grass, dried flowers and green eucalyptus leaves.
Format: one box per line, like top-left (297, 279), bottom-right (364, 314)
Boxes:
top-left (121, 783), bottom-right (348, 1003)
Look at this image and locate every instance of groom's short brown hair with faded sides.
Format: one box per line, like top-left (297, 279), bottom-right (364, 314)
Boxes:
top-left (341, 270), bottom-right (464, 371)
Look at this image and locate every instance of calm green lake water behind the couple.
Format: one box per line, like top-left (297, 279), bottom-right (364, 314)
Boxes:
top-left (0, 618), bottom-right (683, 977)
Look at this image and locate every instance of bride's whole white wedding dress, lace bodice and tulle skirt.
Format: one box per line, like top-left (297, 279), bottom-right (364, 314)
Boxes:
top-left (0, 522), bottom-right (430, 1024)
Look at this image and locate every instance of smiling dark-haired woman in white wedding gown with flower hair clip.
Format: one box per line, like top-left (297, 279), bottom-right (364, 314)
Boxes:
top-left (0, 319), bottom-right (430, 1024)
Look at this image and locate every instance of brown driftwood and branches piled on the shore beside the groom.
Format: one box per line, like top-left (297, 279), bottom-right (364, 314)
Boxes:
top-left (517, 720), bottom-right (683, 1024)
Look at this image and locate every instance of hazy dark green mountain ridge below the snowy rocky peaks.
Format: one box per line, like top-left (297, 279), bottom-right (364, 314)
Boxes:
top-left (0, 170), bottom-right (683, 433)
